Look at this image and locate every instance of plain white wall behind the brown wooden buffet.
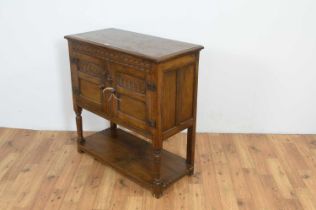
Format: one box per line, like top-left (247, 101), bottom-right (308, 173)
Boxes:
top-left (0, 0), bottom-right (316, 133)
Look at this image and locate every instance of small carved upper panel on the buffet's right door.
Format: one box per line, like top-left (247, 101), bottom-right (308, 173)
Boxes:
top-left (116, 73), bottom-right (146, 94)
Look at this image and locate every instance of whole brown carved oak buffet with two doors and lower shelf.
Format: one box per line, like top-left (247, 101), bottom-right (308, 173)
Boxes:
top-left (65, 29), bottom-right (203, 198)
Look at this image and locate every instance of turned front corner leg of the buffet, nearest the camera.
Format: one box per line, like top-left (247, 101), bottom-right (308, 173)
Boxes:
top-left (153, 135), bottom-right (163, 198)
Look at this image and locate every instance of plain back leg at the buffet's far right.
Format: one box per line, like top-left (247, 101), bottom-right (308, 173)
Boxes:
top-left (187, 125), bottom-right (196, 176)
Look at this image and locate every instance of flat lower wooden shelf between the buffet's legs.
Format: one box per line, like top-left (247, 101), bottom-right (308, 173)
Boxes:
top-left (79, 129), bottom-right (188, 188)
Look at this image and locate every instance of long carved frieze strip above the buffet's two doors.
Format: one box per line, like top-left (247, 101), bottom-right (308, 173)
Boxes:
top-left (72, 42), bottom-right (151, 70)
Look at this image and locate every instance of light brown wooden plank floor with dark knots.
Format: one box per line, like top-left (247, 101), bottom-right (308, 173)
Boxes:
top-left (0, 128), bottom-right (316, 210)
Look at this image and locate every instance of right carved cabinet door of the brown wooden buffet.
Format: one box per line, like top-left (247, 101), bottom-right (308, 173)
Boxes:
top-left (109, 63), bottom-right (148, 129)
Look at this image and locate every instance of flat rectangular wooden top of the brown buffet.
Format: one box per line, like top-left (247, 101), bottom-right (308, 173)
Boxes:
top-left (65, 28), bottom-right (203, 62)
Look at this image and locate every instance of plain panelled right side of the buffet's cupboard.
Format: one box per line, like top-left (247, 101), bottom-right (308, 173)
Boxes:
top-left (159, 54), bottom-right (197, 139)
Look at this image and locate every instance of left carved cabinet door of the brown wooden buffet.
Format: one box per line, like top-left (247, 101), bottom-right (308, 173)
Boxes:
top-left (73, 55), bottom-right (113, 116)
